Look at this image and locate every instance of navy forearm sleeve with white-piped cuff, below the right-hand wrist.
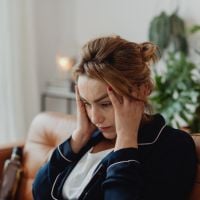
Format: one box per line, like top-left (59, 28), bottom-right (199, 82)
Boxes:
top-left (103, 148), bottom-right (142, 200)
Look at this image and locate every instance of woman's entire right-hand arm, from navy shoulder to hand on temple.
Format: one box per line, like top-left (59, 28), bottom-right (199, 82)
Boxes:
top-left (103, 87), bottom-right (196, 200)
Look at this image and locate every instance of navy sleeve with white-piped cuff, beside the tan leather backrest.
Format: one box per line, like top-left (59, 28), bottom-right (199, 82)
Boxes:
top-left (32, 138), bottom-right (78, 200)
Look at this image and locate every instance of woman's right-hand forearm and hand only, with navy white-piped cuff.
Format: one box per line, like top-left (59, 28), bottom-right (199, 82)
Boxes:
top-left (103, 87), bottom-right (144, 200)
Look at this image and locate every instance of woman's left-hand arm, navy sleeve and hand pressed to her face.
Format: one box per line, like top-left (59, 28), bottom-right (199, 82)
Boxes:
top-left (33, 87), bottom-right (96, 200)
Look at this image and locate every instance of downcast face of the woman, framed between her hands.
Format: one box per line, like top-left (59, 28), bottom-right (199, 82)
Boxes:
top-left (78, 75), bottom-right (116, 139)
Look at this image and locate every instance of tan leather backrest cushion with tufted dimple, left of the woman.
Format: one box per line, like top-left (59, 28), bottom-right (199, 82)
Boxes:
top-left (17, 113), bottom-right (76, 200)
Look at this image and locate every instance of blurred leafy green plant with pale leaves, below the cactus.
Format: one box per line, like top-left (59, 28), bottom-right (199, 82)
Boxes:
top-left (150, 52), bottom-right (200, 128)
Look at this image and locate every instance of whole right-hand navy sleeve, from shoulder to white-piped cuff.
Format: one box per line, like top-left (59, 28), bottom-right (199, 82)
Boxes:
top-left (102, 131), bottom-right (197, 200)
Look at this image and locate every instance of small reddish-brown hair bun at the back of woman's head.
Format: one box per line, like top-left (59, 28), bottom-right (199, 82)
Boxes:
top-left (139, 42), bottom-right (160, 63)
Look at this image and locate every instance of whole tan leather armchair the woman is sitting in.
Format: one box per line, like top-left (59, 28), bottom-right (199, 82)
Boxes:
top-left (0, 113), bottom-right (200, 200)
